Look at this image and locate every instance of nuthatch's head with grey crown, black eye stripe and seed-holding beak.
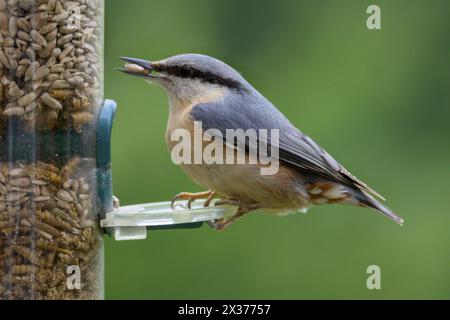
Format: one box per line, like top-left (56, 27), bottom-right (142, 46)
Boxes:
top-left (119, 54), bottom-right (251, 103)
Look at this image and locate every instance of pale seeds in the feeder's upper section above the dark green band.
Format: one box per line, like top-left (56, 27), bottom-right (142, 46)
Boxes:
top-left (0, 0), bottom-right (103, 132)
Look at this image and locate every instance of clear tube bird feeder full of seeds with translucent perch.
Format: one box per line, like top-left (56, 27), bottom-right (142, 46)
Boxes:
top-left (0, 0), bottom-right (234, 299)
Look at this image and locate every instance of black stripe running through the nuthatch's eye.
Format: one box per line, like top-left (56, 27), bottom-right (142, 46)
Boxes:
top-left (155, 65), bottom-right (242, 89)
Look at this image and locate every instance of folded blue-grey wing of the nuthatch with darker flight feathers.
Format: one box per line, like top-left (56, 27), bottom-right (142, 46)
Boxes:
top-left (191, 92), bottom-right (384, 200)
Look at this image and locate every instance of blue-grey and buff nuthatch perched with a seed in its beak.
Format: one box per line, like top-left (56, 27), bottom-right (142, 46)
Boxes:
top-left (120, 54), bottom-right (403, 230)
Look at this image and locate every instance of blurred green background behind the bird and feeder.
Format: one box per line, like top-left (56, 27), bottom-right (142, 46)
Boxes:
top-left (105, 0), bottom-right (450, 299)
